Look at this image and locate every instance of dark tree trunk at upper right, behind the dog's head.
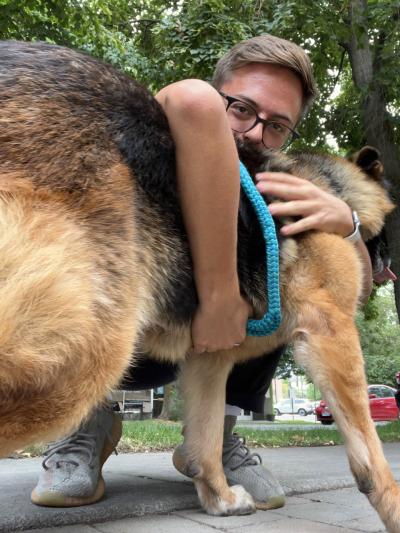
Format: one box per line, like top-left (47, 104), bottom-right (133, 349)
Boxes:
top-left (347, 0), bottom-right (400, 317)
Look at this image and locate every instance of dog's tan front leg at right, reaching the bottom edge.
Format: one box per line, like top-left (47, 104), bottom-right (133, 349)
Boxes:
top-left (295, 295), bottom-right (400, 533)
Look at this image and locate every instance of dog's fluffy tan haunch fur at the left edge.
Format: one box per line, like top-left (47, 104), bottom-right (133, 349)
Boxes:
top-left (0, 183), bottom-right (135, 457)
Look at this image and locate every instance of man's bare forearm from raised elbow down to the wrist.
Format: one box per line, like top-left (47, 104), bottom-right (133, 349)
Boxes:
top-left (157, 80), bottom-right (240, 301)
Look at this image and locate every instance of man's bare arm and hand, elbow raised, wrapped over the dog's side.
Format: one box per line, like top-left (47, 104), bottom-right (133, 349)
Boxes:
top-left (156, 80), bottom-right (250, 352)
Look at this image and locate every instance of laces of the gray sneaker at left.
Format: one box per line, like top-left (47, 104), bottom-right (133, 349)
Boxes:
top-left (42, 431), bottom-right (96, 470)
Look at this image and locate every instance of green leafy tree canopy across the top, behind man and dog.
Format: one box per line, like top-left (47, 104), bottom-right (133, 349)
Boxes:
top-left (0, 0), bottom-right (400, 151)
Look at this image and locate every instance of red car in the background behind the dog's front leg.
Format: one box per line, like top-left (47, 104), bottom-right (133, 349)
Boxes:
top-left (315, 385), bottom-right (399, 425)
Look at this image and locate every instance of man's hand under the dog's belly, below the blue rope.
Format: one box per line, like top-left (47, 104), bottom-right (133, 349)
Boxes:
top-left (192, 291), bottom-right (251, 353)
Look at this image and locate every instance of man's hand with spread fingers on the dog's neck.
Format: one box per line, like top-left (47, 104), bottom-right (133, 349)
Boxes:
top-left (256, 172), bottom-right (354, 237)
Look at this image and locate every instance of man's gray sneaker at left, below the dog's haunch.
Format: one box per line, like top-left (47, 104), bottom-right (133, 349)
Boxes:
top-left (31, 407), bottom-right (122, 507)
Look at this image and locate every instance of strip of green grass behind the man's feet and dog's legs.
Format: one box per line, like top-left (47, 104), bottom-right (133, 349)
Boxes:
top-left (14, 420), bottom-right (400, 457)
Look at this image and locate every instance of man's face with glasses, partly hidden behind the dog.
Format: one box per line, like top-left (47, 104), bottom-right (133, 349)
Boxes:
top-left (220, 63), bottom-right (303, 150)
